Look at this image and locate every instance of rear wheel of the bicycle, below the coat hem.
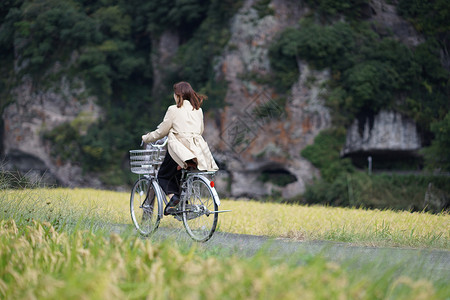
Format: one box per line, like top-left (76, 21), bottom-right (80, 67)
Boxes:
top-left (182, 177), bottom-right (218, 242)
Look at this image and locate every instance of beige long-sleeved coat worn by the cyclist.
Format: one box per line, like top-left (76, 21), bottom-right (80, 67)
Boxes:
top-left (142, 100), bottom-right (219, 171)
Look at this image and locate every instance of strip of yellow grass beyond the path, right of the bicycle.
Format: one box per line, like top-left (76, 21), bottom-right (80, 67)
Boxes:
top-left (220, 201), bottom-right (450, 249)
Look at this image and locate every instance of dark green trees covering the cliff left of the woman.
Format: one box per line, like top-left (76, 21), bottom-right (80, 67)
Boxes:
top-left (0, 0), bottom-right (240, 184)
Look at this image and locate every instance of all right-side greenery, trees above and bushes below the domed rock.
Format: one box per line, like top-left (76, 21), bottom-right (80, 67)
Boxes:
top-left (270, 0), bottom-right (450, 210)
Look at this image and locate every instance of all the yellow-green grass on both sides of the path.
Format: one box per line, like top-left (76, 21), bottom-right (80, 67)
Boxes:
top-left (0, 189), bottom-right (450, 299)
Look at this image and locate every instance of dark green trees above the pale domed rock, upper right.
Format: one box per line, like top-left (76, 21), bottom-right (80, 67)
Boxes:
top-left (270, 0), bottom-right (450, 173)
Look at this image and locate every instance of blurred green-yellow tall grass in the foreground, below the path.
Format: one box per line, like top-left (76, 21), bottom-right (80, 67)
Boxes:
top-left (0, 220), bottom-right (450, 299)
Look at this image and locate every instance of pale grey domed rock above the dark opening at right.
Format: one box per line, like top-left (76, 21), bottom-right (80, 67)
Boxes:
top-left (342, 111), bottom-right (421, 155)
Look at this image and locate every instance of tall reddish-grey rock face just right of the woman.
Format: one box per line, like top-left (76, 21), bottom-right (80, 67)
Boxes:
top-left (205, 1), bottom-right (330, 198)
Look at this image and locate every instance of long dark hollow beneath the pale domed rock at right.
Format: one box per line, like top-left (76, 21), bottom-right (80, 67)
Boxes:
top-left (346, 150), bottom-right (424, 171)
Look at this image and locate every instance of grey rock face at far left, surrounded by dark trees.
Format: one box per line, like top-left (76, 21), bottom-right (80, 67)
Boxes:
top-left (2, 76), bottom-right (101, 187)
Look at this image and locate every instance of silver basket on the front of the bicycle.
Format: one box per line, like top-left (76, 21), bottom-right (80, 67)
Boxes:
top-left (130, 147), bottom-right (166, 174)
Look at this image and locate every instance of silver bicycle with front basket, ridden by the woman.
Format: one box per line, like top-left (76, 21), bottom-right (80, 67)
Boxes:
top-left (130, 139), bottom-right (229, 242)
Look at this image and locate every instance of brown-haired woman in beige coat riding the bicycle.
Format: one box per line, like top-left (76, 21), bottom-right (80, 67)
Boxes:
top-left (142, 81), bottom-right (219, 215)
